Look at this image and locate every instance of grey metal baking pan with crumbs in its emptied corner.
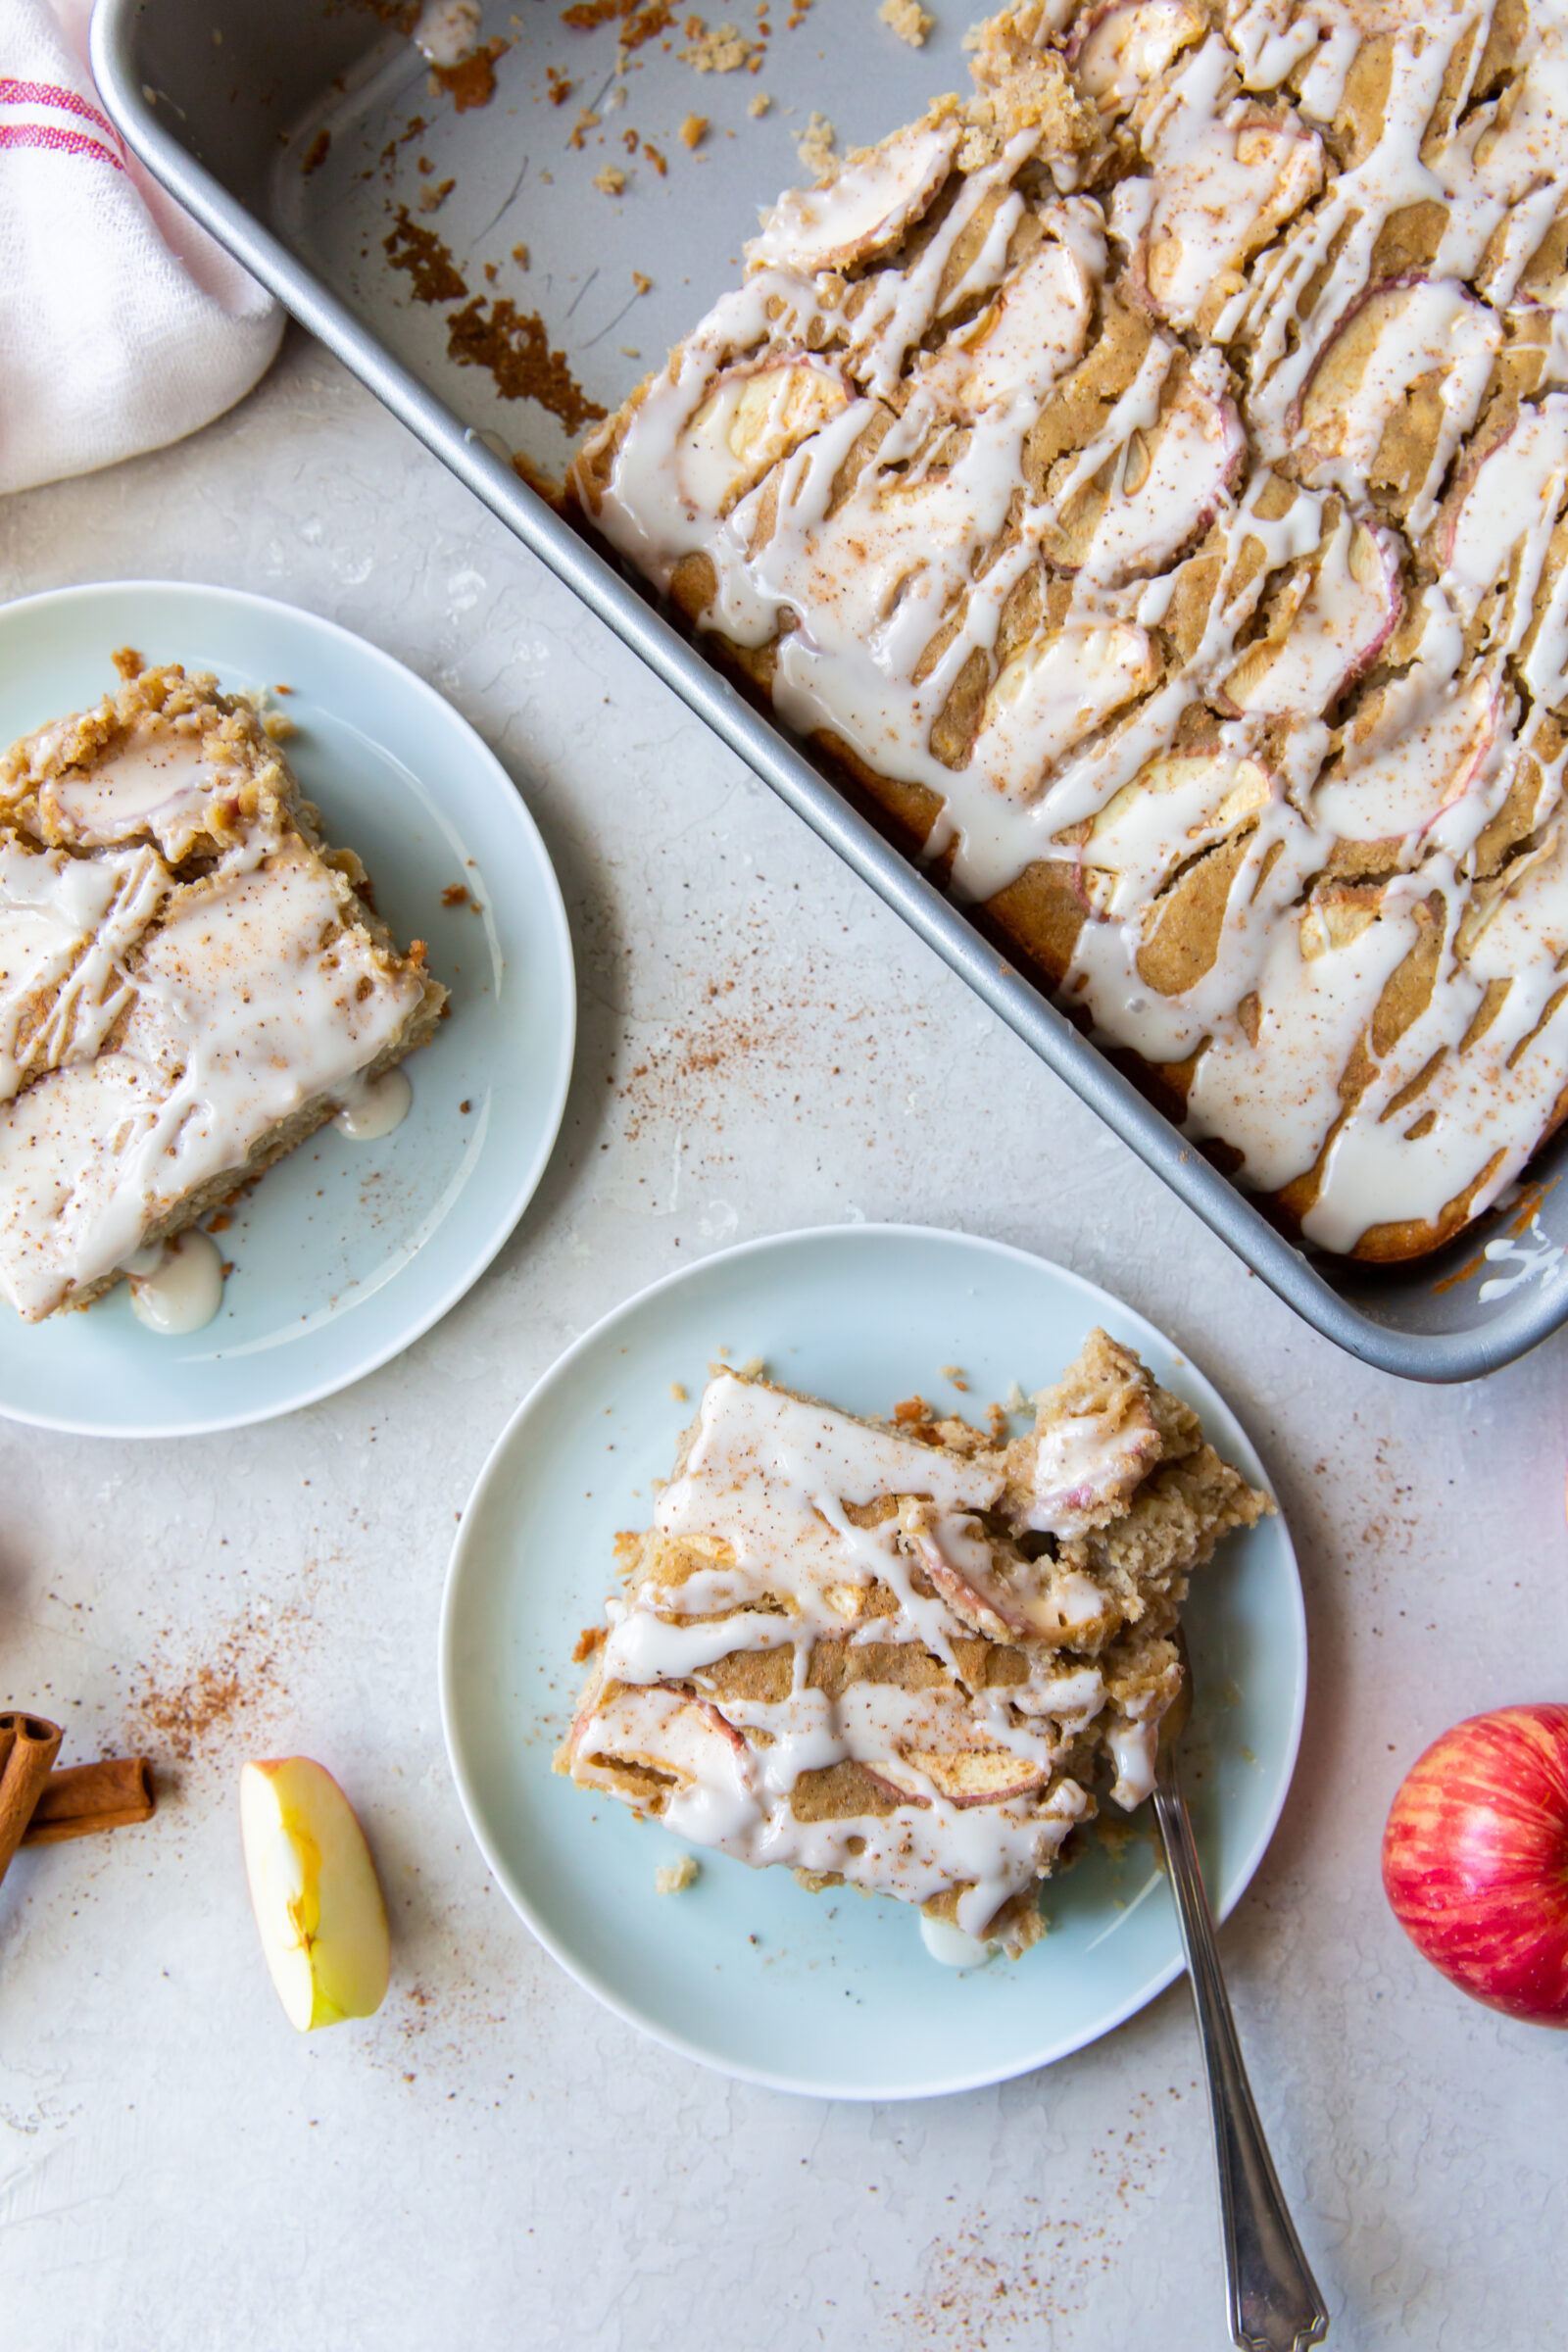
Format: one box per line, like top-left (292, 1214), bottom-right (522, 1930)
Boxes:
top-left (92, 0), bottom-right (1568, 1381)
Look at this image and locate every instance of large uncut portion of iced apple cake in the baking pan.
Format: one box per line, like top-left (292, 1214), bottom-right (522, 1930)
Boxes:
top-left (571, 0), bottom-right (1568, 1258)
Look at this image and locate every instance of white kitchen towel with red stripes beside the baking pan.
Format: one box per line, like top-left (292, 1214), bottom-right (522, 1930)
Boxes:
top-left (0, 0), bottom-right (282, 492)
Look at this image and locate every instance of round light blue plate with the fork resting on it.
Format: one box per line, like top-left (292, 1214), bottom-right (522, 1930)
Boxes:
top-left (442, 1225), bottom-right (1307, 2098)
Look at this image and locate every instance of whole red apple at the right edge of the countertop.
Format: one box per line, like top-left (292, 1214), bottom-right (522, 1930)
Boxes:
top-left (1382, 1703), bottom-right (1568, 2025)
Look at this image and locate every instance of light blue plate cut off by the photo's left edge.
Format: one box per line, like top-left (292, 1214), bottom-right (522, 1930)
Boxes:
top-left (0, 581), bottom-right (576, 1437)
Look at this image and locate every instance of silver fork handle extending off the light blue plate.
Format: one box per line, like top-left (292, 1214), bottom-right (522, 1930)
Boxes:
top-left (1154, 1757), bottom-right (1328, 2352)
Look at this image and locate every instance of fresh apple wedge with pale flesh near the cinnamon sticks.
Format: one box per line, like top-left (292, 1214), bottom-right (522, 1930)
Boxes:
top-left (240, 1757), bottom-right (390, 2034)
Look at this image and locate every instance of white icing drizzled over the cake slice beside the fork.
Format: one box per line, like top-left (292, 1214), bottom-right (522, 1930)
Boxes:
top-left (569, 1374), bottom-right (1194, 1936)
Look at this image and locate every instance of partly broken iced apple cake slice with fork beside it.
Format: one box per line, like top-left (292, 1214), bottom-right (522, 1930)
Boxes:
top-left (555, 1331), bottom-right (1272, 1952)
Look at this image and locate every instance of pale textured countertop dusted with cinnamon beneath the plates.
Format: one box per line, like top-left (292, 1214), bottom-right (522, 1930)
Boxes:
top-left (0, 334), bottom-right (1568, 2352)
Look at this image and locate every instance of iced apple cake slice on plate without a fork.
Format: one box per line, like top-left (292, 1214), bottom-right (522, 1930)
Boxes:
top-left (0, 654), bottom-right (447, 1322)
